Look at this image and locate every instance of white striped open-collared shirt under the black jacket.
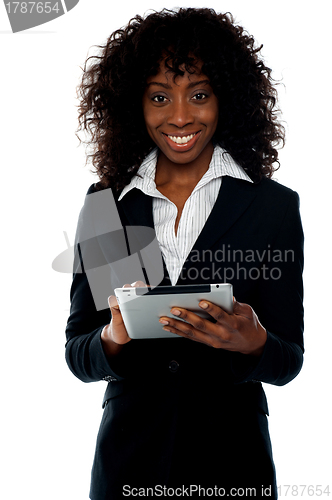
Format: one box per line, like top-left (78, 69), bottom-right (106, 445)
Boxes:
top-left (119, 145), bottom-right (253, 286)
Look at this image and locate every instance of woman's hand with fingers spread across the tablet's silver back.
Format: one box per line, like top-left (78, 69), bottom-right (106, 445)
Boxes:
top-left (159, 298), bottom-right (267, 356)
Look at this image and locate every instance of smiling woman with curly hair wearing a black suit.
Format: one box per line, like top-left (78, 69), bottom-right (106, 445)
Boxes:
top-left (66, 5), bottom-right (303, 500)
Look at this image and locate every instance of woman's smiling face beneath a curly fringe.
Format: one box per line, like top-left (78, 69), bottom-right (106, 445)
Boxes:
top-left (143, 62), bottom-right (218, 164)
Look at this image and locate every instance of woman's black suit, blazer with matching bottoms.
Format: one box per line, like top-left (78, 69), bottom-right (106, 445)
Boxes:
top-left (66, 177), bottom-right (304, 500)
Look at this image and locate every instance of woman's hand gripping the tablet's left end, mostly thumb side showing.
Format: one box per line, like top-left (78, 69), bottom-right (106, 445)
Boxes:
top-left (101, 281), bottom-right (147, 357)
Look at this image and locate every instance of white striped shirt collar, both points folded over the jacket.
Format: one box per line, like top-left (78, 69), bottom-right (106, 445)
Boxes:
top-left (118, 145), bottom-right (253, 201)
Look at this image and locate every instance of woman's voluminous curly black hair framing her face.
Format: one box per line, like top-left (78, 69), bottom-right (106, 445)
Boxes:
top-left (77, 8), bottom-right (285, 191)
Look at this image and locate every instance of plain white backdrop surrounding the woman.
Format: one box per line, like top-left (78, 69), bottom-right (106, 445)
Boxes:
top-left (0, 0), bottom-right (332, 500)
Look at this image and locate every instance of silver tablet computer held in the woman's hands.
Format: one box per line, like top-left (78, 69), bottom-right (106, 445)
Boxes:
top-left (114, 283), bottom-right (233, 339)
